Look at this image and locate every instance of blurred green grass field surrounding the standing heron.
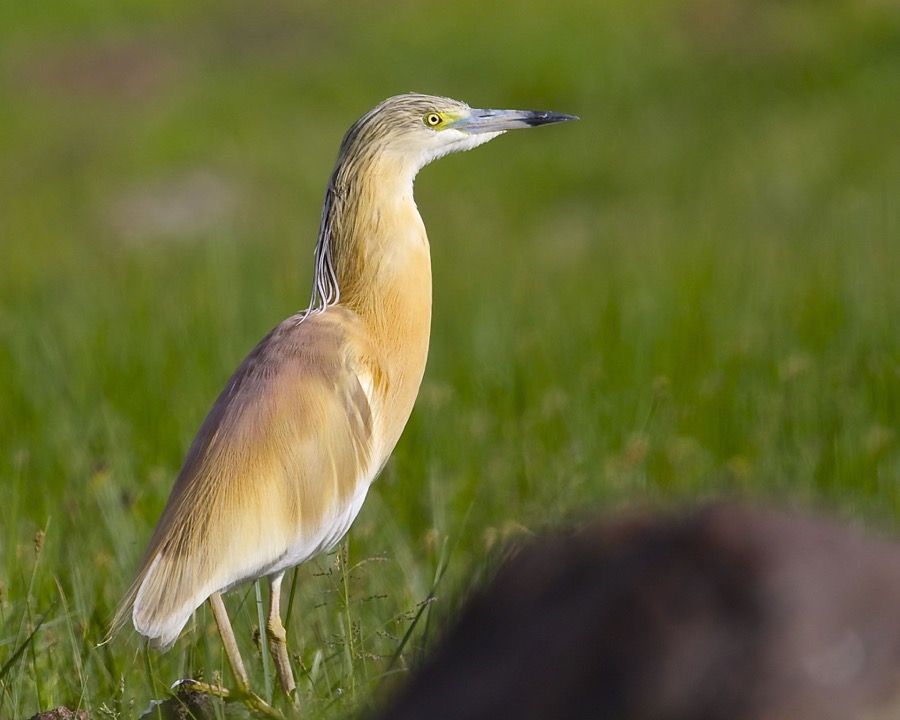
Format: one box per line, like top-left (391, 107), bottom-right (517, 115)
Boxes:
top-left (0, 0), bottom-right (900, 719)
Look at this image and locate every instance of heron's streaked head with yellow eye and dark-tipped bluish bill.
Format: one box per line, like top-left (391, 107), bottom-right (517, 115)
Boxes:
top-left (341, 93), bottom-right (577, 174)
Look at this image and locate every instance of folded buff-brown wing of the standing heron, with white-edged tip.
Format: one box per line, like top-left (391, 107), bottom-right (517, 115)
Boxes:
top-left (114, 308), bottom-right (382, 648)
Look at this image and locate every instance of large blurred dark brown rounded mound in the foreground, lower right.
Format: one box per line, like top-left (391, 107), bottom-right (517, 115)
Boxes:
top-left (380, 505), bottom-right (900, 720)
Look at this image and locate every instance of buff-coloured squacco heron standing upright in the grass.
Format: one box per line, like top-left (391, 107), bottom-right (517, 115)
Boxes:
top-left (114, 94), bottom-right (575, 695)
